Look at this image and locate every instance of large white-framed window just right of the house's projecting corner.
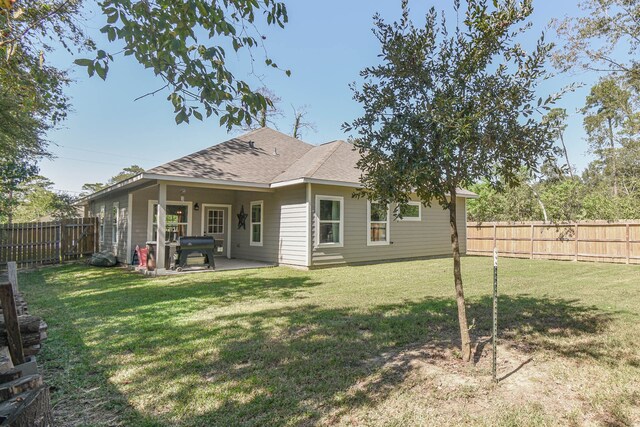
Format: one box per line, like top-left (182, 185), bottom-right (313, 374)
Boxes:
top-left (316, 196), bottom-right (344, 247)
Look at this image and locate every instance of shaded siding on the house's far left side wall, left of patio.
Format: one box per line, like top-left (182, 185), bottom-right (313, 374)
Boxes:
top-left (88, 193), bottom-right (131, 263)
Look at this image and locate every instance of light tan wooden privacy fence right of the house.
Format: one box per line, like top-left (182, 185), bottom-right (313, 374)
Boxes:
top-left (467, 221), bottom-right (640, 264)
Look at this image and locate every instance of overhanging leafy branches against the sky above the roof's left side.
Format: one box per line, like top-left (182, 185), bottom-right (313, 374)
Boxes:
top-left (76, 0), bottom-right (290, 129)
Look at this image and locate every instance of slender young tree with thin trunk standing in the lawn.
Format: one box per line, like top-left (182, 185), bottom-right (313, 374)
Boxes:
top-left (345, 0), bottom-right (559, 361)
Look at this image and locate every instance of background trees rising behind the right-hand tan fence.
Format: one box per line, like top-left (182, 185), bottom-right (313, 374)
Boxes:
top-left (468, 0), bottom-right (640, 222)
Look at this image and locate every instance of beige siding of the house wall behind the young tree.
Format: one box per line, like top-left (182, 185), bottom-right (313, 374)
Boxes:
top-left (311, 185), bottom-right (466, 266)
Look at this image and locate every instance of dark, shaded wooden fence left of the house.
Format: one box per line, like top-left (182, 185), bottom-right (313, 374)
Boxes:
top-left (0, 218), bottom-right (98, 269)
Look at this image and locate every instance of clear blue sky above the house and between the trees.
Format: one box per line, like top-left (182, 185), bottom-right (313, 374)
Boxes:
top-left (41, 0), bottom-right (598, 192)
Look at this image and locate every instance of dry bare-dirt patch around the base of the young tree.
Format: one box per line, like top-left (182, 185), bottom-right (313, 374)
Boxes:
top-left (323, 337), bottom-right (596, 425)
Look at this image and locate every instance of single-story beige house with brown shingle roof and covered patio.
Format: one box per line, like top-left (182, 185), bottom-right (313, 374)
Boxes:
top-left (82, 128), bottom-right (475, 270)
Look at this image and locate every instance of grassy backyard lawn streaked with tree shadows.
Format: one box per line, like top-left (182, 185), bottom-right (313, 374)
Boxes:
top-left (20, 257), bottom-right (640, 426)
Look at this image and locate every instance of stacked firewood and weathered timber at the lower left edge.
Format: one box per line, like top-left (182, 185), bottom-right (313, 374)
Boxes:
top-left (0, 263), bottom-right (53, 427)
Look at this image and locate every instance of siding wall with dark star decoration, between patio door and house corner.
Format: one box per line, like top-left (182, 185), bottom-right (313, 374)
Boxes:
top-left (231, 185), bottom-right (307, 266)
